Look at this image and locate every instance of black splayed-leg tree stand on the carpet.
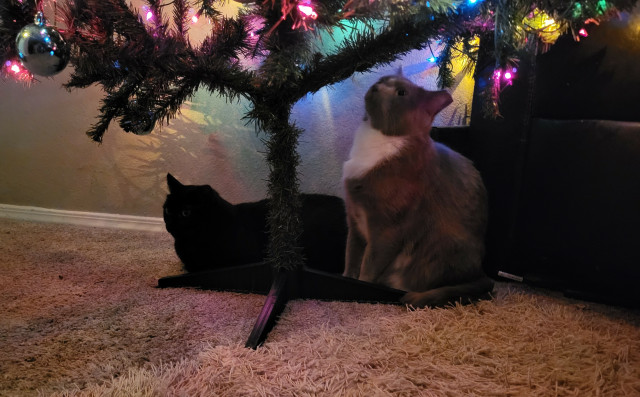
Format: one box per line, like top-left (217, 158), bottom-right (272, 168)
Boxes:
top-left (158, 263), bottom-right (405, 349)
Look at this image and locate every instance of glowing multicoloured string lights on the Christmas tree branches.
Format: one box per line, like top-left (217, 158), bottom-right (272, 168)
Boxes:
top-left (0, 0), bottom-right (634, 96)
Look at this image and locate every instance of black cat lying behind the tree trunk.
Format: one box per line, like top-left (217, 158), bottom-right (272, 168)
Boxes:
top-left (164, 174), bottom-right (347, 273)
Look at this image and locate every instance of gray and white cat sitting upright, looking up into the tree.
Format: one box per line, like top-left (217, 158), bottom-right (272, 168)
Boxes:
top-left (343, 75), bottom-right (493, 307)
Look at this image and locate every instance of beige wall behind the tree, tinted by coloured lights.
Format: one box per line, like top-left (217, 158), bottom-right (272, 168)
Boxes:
top-left (0, 48), bottom-right (473, 216)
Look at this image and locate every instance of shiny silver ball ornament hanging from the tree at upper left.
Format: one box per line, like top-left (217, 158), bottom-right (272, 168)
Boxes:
top-left (16, 11), bottom-right (71, 76)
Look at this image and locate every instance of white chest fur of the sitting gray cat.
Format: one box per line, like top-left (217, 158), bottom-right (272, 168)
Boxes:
top-left (342, 121), bottom-right (406, 180)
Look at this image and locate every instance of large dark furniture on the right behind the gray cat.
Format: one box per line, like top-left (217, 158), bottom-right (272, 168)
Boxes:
top-left (450, 10), bottom-right (640, 307)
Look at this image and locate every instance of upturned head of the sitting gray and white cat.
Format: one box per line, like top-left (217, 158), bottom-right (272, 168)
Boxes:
top-left (364, 75), bottom-right (453, 136)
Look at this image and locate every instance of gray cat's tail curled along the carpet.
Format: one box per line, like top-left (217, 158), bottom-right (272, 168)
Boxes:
top-left (400, 276), bottom-right (493, 308)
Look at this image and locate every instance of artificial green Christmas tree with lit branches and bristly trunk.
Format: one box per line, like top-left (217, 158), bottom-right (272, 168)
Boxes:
top-left (0, 0), bottom-right (636, 345)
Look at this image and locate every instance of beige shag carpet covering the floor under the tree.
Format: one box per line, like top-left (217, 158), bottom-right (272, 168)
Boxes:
top-left (0, 219), bottom-right (640, 397)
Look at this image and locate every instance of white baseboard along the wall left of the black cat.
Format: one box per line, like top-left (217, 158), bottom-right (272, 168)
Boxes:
top-left (0, 204), bottom-right (166, 232)
